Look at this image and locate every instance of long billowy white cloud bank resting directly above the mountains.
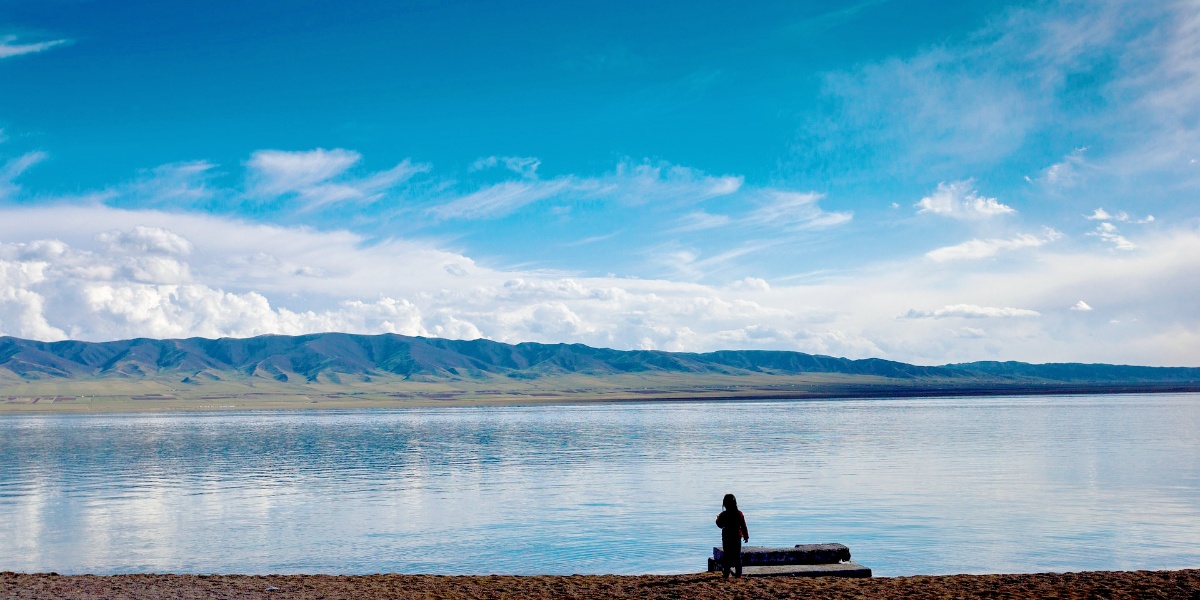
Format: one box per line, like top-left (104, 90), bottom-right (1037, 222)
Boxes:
top-left (0, 205), bottom-right (1200, 365)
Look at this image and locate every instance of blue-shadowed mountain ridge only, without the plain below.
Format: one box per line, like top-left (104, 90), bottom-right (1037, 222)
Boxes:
top-left (0, 332), bottom-right (1200, 384)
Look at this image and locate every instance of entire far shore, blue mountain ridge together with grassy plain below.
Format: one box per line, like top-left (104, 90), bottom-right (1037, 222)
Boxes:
top-left (9, 332), bottom-right (1200, 414)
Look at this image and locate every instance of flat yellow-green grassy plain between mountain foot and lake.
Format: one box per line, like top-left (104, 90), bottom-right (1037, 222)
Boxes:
top-left (0, 373), bottom-right (1198, 414)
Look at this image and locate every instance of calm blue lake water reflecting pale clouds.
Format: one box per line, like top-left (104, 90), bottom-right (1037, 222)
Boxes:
top-left (0, 394), bottom-right (1200, 575)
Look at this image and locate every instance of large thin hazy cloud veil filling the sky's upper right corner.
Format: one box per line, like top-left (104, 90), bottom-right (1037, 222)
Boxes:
top-left (796, 0), bottom-right (1200, 192)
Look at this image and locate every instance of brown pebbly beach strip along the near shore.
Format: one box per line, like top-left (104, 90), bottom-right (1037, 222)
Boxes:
top-left (0, 569), bottom-right (1200, 600)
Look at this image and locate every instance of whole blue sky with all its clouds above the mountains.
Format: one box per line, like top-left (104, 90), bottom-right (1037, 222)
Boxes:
top-left (0, 0), bottom-right (1200, 366)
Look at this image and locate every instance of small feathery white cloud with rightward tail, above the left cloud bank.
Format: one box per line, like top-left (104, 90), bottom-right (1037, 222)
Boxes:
top-left (246, 148), bottom-right (430, 209)
